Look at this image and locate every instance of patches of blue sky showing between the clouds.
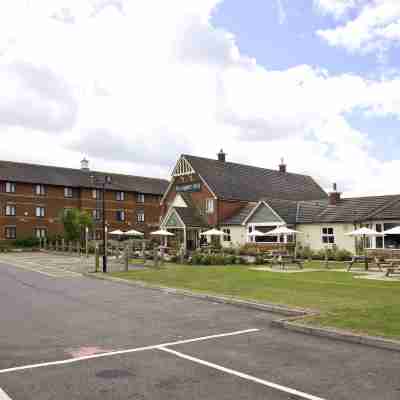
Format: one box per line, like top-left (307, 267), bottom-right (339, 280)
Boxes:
top-left (212, 0), bottom-right (400, 160)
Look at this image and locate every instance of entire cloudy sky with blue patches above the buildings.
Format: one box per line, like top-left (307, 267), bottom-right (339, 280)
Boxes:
top-left (0, 0), bottom-right (400, 196)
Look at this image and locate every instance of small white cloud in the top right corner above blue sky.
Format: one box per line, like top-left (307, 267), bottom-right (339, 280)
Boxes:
top-left (317, 0), bottom-right (400, 54)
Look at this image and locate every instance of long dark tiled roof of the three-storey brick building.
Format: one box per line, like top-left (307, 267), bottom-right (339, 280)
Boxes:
top-left (0, 161), bottom-right (168, 195)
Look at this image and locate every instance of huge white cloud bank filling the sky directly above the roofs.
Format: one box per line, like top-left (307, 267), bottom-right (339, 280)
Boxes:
top-left (0, 0), bottom-right (400, 197)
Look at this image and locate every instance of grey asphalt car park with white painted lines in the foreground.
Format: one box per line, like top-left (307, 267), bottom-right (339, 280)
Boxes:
top-left (0, 256), bottom-right (400, 400)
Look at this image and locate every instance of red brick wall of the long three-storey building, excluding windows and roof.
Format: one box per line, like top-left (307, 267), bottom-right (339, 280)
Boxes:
top-left (0, 182), bottom-right (161, 240)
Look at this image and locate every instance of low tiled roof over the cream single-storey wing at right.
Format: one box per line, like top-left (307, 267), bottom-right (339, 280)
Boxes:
top-left (297, 195), bottom-right (400, 223)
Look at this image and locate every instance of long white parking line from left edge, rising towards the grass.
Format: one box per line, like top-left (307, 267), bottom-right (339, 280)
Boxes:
top-left (0, 329), bottom-right (259, 376)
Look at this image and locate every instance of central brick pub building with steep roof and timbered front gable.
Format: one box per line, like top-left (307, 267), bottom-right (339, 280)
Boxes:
top-left (161, 150), bottom-right (327, 249)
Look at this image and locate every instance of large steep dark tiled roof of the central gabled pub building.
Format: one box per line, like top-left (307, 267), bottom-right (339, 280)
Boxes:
top-left (183, 155), bottom-right (327, 201)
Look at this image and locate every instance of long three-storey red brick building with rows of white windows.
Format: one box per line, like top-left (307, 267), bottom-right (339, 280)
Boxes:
top-left (0, 160), bottom-right (168, 240)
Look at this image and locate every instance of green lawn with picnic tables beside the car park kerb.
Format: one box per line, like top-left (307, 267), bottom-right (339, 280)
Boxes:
top-left (113, 263), bottom-right (400, 339)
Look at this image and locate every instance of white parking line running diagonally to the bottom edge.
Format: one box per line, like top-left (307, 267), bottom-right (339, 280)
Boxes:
top-left (158, 346), bottom-right (324, 400)
